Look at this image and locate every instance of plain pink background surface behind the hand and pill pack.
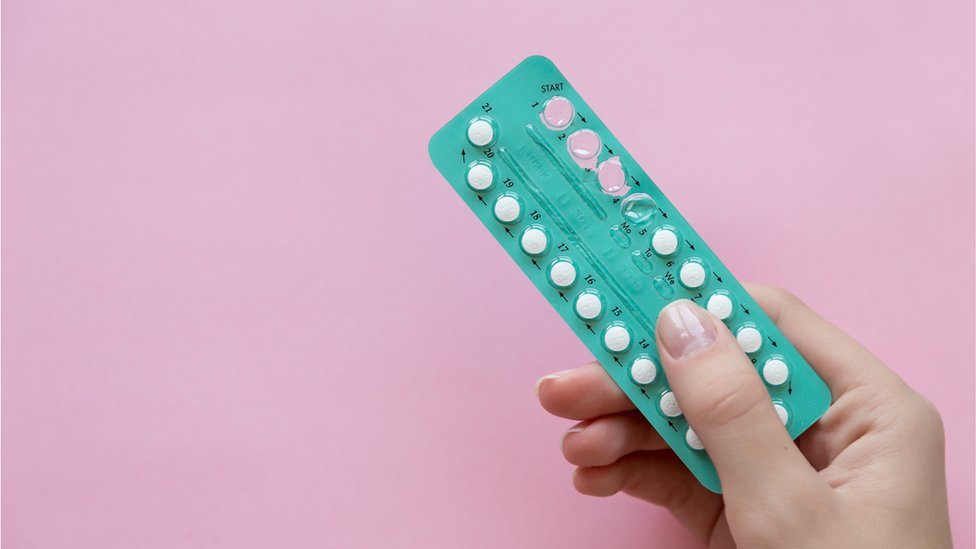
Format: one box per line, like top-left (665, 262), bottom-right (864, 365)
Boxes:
top-left (2, 0), bottom-right (976, 548)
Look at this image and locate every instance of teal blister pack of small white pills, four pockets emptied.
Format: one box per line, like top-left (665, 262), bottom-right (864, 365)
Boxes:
top-left (429, 56), bottom-right (831, 492)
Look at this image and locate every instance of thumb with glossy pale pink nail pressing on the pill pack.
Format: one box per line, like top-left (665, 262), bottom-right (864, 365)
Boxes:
top-left (656, 300), bottom-right (820, 501)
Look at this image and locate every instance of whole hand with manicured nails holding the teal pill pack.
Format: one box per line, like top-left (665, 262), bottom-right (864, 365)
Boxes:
top-left (536, 285), bottom-right (952, 549)
